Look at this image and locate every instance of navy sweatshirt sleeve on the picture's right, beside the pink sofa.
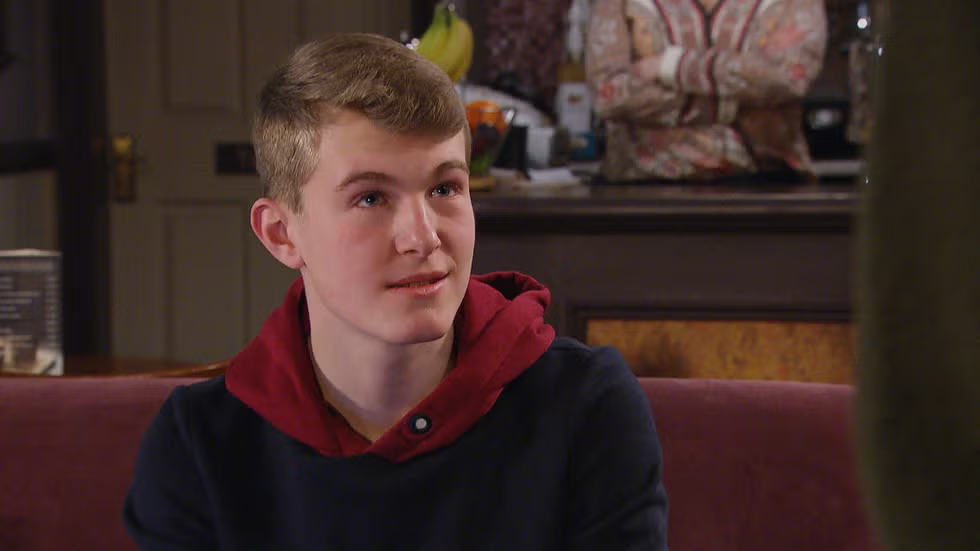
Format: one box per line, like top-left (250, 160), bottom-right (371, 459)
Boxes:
top-left (564, 347), bottom-right (667, 551)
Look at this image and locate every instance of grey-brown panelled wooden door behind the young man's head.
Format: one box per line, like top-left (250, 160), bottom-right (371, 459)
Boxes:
top-left (105, 0), bottom-right (410, 362)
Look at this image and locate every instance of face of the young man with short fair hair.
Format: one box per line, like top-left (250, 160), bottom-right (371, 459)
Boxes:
top-left (288, 112), bottom-right (475, 344)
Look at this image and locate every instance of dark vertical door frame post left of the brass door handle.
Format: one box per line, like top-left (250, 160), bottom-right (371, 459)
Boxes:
top-left (48, 0), bottom-right (112, 358)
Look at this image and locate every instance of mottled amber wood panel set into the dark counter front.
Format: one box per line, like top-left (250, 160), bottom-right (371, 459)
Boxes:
top-left (586, 319), bottom-right (855, 383)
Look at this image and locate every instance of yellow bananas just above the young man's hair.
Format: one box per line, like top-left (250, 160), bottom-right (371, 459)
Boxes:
top-left (413, 2), bottom-right (473, 82)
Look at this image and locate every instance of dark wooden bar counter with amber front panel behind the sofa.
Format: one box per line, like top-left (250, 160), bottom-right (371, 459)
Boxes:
top-left (473, 183), bottom-right (858, 382)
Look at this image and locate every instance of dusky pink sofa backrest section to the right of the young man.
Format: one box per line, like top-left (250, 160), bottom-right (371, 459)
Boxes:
top-left (640, 379), bottom-right (878, 551)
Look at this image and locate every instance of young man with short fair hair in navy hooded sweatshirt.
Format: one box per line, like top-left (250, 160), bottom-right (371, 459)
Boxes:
top-left (124, 35), bottom-right (667, 550)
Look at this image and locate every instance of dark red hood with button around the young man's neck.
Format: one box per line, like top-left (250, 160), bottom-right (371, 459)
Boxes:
top-left (225, 272), bottom-right (555, 462)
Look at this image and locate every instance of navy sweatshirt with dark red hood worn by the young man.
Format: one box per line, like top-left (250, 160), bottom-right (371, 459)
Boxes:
top-left (124, 274), bottom-right (667, 551)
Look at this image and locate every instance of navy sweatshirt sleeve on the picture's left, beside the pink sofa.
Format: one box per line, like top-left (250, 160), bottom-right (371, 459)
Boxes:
top-left (123, 388), bottom-right (218, 551)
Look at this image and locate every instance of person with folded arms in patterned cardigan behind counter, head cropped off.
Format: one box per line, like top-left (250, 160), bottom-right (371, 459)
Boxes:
top-left (586, 0), bottom-right (827, 180)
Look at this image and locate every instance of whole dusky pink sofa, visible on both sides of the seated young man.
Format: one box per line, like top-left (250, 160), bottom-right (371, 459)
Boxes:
top-left (0, 377), bottom-right (876, 551)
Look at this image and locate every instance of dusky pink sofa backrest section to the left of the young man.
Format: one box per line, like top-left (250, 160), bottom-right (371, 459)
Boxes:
top-left (0, 377), bottom-right (199, 551)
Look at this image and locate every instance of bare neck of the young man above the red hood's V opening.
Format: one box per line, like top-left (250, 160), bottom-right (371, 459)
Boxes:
top-left (309, 328), bottom-right (453, 442)
